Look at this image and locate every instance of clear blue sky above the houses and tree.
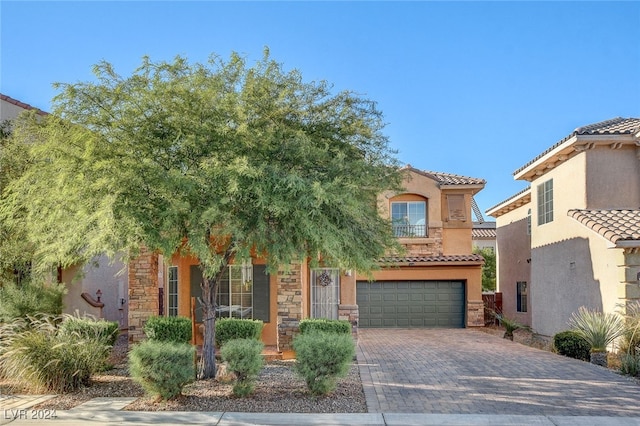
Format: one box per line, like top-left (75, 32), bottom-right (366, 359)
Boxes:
top-left (0, 0), bottom-right (640, 212)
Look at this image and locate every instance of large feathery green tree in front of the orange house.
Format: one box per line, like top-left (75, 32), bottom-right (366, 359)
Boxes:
top-left (0, 50), bottom-right (400, 378)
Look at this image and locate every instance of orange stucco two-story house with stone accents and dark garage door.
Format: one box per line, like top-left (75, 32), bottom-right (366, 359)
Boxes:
top-left (129, 166), bottom-right (485, 353)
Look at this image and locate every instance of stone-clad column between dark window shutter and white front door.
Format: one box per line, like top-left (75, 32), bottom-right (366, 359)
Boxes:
top-left (277, 264), bottom-right (303, 353)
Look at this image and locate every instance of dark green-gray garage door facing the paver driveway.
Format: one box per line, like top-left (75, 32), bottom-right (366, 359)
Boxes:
top-left (357, 281), bottom-right (464, 328)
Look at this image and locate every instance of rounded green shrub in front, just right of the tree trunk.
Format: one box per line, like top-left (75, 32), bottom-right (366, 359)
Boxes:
top-left (220, 339), bottom-right (264, 396)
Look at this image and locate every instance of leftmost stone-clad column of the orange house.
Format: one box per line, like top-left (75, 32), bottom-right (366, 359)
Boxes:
top-left (129, 248), bottom-right (159, 342)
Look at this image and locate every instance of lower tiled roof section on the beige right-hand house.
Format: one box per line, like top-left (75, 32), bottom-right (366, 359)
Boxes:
top-left (567, 210), bottom-right (640, 244)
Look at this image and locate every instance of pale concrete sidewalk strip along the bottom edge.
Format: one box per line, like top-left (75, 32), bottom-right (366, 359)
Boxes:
top-left (3, 409), bottom-right (640, 426)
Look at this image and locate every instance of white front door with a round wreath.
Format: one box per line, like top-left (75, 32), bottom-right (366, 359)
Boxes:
top-left (311, 268), bottom-right (340, 319)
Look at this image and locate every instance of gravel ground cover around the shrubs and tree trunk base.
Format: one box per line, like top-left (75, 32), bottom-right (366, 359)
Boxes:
top-left (14, 335), bottom-right (367, 413)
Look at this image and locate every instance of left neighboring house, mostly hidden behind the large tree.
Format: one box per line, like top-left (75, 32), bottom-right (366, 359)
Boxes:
top-left (0, 94), bottom-right (129, 329)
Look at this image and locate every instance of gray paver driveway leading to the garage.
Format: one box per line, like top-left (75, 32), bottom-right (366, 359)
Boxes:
top-left (357, 329), bottom-right (640, 416)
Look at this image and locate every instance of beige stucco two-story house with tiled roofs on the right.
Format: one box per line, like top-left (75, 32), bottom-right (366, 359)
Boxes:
top-left (487, 118), bottom-right (640, 336)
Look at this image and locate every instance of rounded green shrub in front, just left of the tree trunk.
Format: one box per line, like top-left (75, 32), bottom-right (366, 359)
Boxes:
top-left (129, 340), bottom-right (196, 399)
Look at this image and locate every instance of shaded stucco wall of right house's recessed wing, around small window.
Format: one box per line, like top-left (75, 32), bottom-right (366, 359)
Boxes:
top-left (496, 204), bottom-right (537, 326)
